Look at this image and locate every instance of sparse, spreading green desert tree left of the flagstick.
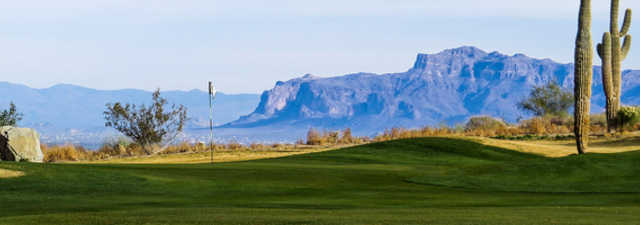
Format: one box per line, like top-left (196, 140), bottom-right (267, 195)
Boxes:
top-left (104, 89), bottom-right (187, 155)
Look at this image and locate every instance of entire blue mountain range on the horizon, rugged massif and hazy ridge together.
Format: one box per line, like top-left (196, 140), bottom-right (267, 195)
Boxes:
top-left (0, 46), bottom-right (640, 148)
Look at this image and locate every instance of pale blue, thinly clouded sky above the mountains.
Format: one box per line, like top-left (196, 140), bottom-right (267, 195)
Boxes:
top-left (0, 0), bottom-right (640, 94)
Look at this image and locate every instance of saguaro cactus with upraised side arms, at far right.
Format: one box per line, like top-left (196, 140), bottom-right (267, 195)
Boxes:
top-left (598, 0), bottom-right (632, 132)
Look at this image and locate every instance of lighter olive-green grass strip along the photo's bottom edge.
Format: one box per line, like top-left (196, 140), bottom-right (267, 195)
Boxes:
top-left (0, 207), bottom-right (640, 225)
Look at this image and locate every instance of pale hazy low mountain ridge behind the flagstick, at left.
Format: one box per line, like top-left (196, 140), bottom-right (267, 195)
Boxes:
top-left (0, 82), bottom-right (259, 135)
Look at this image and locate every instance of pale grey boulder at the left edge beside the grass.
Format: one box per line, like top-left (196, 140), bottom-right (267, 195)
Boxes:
top-left (0, 126), bottom-right (44, 162)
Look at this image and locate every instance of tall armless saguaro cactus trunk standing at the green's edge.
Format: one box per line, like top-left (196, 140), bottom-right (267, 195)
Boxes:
top-left (574, 0), bottom-right (593, 154)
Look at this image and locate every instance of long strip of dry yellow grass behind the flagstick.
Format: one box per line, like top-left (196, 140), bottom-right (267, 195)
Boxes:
top-left (87, 146), bottom-right (348, 164)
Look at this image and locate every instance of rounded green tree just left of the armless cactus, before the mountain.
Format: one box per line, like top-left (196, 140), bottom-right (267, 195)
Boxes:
top-left (518, 82), bottom-right (574, 117)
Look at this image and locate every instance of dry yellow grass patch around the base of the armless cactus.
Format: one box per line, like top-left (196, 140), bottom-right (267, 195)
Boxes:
top-left (465, 134), bottom-right (640, 157)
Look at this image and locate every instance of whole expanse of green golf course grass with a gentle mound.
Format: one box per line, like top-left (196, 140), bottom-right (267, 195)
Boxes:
top-left (0, 138), bottom-right (640, 225)
